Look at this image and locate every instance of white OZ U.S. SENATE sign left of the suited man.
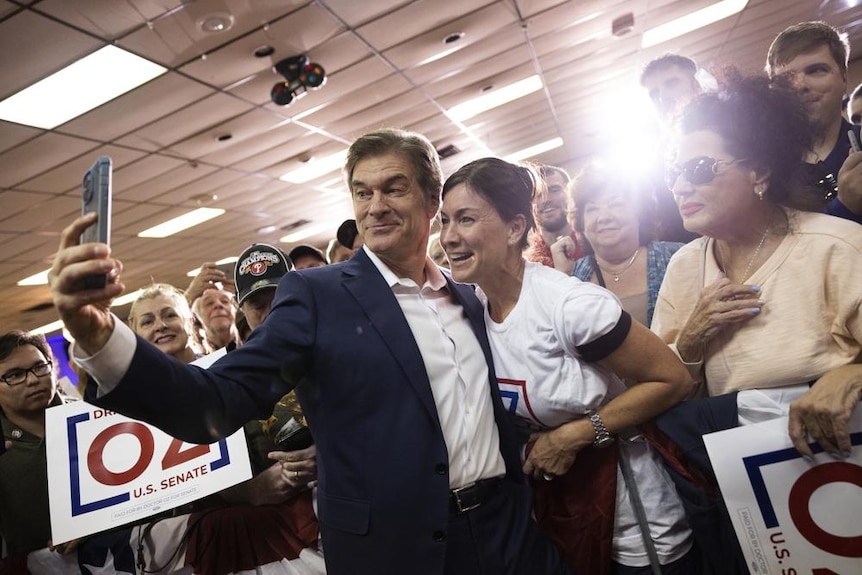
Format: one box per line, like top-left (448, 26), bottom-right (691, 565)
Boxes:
top-left (45, 401), bottom-right (251, 544)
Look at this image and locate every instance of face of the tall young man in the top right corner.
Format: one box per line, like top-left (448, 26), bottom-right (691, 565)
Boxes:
top-left (775, 44), bottom-right (847, 130)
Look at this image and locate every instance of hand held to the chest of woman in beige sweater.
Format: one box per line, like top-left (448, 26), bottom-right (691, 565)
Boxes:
top-left (676, 276), bottom-right (765, 363)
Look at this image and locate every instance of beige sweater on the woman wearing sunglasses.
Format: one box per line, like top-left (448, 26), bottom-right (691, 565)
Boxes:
top-left (652, 210), bottom-right (862, 395)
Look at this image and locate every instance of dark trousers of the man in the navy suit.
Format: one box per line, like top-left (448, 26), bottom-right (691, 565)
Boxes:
top-left (445, 480), bottom-right (571, 575)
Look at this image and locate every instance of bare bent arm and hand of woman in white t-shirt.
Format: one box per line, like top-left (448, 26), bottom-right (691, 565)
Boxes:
top-left (524, 321), bottom-right (693, 475)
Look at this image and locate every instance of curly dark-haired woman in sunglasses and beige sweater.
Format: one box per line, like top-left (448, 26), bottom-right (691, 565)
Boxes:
top-left (652, 76), bottom-right (862, 572)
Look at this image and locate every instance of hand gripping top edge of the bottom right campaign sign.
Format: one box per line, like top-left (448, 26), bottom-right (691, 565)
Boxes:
top-left (787, 364), bottom-right (862, 460)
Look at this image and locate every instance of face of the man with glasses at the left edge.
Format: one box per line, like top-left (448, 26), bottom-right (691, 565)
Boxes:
top-left (0, 344), bottom-right (57, 418)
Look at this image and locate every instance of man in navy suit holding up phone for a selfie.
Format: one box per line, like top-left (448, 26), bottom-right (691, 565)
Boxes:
top-left (51, 130), bottom-right (567, 575)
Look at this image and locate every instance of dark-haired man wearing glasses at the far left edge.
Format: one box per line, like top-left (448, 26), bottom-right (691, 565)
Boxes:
top-left (0, 331), bottom-right (63, 555)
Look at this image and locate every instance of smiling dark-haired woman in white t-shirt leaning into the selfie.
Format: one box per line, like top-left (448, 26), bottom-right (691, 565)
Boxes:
top-left (441, 158), bottom-right (700, 575)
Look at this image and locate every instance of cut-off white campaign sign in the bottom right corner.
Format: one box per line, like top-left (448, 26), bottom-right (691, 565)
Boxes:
top-left (703, 408), bottom-right (862, 575)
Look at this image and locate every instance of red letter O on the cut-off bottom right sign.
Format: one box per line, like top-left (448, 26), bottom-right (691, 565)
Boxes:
top-left (788, 462), bottom-right (862, 557)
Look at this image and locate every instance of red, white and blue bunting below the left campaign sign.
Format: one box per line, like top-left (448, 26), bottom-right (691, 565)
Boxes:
top-left (5, 491), bottom-right (326, 575)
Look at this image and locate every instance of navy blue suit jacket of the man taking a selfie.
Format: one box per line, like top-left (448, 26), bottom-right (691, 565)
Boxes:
top-left (97, 250), bottom-right (528, 575)
